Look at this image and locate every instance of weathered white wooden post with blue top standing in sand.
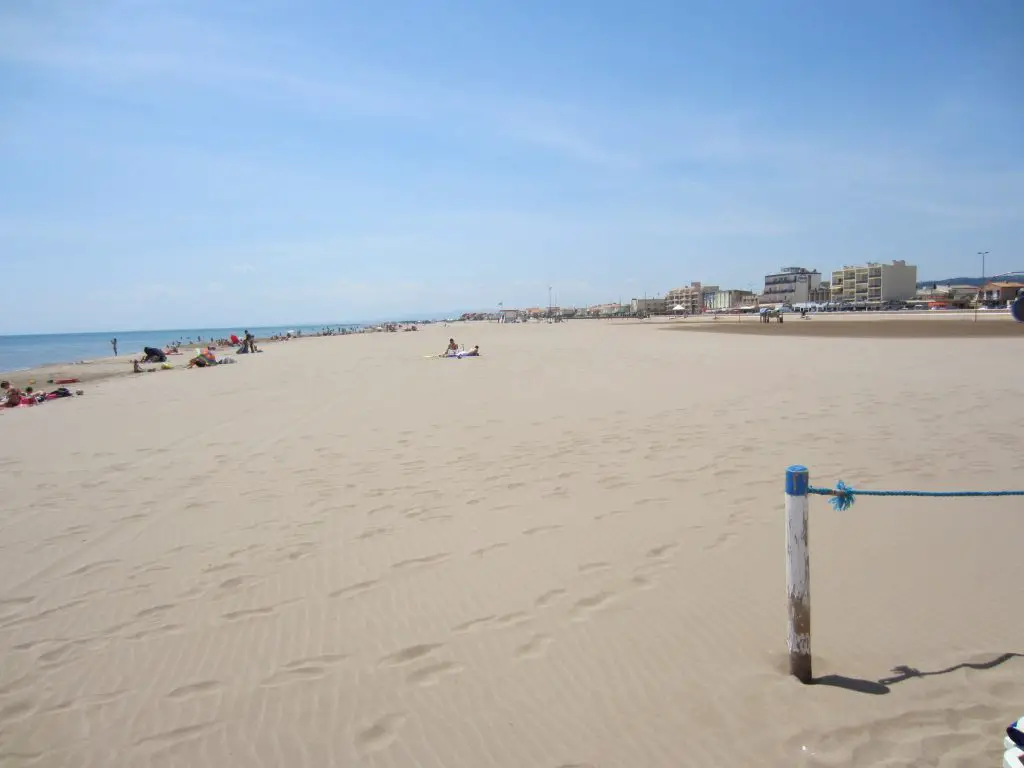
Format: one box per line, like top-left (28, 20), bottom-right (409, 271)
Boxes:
top-left (785, 465), bottom-right (812, 683)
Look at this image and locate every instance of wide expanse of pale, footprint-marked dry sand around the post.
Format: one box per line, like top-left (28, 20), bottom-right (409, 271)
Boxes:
top-left (0, 318), bottom-right (1024, 768)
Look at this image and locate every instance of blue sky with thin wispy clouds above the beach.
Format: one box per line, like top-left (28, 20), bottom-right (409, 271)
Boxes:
top-left (0, 0), bottom-right (1024, 333)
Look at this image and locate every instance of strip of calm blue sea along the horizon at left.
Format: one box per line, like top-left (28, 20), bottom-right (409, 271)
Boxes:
top-left (0, 324), bottom-right (360, 371)
